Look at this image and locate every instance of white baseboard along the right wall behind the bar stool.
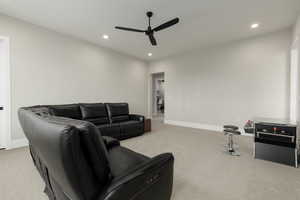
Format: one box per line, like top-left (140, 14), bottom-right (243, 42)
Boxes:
top-left (164, 120), bottom-right (253, 137)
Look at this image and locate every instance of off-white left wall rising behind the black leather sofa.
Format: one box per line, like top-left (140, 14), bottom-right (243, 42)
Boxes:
top-left (0, 15), bottom-right (147, 140)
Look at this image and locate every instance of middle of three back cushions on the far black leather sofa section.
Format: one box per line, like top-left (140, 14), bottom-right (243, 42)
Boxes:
top-left (80, 103), bottom-right (108, 120)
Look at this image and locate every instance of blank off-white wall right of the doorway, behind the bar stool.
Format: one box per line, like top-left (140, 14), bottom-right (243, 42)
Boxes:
top-left (149, 30), bottom-right (292, 128)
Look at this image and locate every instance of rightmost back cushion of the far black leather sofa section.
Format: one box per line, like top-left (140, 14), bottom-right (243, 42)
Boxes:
top-left (106, 103), bottom-right (129, 123)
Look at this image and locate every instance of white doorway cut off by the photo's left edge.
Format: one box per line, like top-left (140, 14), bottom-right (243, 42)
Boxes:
top-left (0, 36), bottom-right (10, 149)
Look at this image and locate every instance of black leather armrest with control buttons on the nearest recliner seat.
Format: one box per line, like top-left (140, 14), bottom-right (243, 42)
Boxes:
top-left (98, 153), bottom-right (174, 200)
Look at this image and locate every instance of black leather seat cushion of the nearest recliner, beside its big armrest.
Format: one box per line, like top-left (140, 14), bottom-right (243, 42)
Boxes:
top-left (108, 146), bottom-right (150, 177)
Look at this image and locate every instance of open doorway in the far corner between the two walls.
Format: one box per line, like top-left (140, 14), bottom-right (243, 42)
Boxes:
top-left (152, 73), bottom-right (165, 121)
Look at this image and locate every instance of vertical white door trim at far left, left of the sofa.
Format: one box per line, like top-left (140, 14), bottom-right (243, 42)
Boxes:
top-left (0, 36), bottom-right (11, 148)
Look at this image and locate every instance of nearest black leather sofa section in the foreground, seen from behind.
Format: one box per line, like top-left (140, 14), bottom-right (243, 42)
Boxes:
top-left (18, 106), bottom-right (174, 200)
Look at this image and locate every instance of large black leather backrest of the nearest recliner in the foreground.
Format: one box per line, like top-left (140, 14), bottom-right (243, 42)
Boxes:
top-left (19, 108), bottom-right (110, 200)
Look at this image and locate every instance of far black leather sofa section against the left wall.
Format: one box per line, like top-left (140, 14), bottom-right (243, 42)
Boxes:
top-left (35, 103), bottom-right (144, 140)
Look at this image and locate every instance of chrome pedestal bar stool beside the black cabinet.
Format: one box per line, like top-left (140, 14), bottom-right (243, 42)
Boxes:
top-left (223, 125), bottom-right (241, 156)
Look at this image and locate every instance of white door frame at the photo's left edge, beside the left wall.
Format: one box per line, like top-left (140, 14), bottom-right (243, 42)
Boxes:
top-left (0, 36), bottom-right (11, 149)
